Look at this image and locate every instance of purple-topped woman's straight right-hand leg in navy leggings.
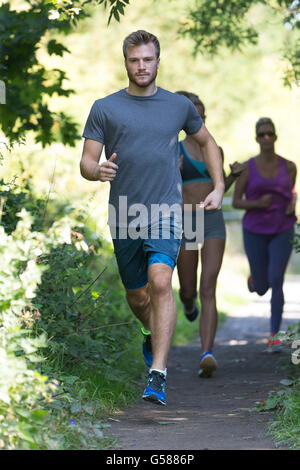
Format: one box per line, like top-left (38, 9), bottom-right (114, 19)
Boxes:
top-left (269, 228), bottom-right (294, 334)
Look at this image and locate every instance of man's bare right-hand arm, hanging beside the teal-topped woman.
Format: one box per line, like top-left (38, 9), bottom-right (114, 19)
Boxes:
top-left (191, 124), bottom-right (225, 210)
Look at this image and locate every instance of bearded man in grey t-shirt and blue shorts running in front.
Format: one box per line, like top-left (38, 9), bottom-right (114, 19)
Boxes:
top-left (80, 30), bottom-right (224, 405)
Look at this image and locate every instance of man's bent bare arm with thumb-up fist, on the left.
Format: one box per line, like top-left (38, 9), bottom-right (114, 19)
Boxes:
top-left (80, 139), bottom-right (119, 182)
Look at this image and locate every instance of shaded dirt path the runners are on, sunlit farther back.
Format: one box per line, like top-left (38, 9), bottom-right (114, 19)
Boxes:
top-left (109, 277), bottom-right (300, 450)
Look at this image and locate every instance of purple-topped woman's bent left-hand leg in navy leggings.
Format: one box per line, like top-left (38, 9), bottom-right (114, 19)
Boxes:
top-left (243, 229), bottom-right (270, 295)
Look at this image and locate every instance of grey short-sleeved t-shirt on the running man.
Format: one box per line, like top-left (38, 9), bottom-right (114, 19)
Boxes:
top-left (83, 88), bottom-right (202, 227)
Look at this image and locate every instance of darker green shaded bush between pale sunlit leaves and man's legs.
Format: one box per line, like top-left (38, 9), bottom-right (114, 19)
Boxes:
top-left (34, 231), bottom-right (133, 367)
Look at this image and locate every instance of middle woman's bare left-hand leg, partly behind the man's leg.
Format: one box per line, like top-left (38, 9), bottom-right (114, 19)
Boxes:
top-left (177, 248), bottom-right (199, 312)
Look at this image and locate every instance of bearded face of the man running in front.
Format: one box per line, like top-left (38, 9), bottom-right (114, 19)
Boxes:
top-left (125, 42), bottom-right (159, 88)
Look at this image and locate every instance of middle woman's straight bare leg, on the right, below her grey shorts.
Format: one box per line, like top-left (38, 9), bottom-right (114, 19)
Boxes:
top-left (200, 238), bottom-right (225, 352)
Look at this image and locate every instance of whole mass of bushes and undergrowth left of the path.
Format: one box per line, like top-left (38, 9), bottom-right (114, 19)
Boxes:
top-left (0, 175), bottom-right (142, 449)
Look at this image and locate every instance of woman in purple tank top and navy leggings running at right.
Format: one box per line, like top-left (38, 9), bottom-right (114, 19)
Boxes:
top-left (233, 118), bottom-right (297, 351)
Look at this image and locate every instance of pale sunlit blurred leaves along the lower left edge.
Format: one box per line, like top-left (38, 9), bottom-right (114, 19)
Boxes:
top-left (0, 209), bottom-right (54, 449)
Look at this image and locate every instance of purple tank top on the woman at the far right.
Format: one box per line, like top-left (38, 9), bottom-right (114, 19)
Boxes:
top-left (243, 157), bottom-right (297, 234)
